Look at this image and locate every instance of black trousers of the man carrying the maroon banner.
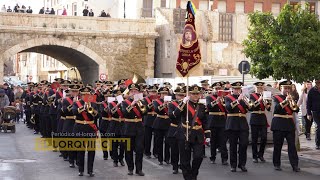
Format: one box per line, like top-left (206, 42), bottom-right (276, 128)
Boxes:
top-left (179, 140), bottom-right (203, 180)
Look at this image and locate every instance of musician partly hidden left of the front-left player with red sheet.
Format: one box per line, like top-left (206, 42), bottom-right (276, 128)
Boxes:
top-left (61, 85), bottom-right (80, 168)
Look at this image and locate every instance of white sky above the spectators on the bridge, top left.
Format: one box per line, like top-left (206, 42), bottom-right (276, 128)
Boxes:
top-left (0, 0), bottom-right (43, 11)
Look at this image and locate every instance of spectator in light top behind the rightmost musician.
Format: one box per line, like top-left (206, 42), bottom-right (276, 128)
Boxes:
top-left (298, 81), bottom-right (313, 141)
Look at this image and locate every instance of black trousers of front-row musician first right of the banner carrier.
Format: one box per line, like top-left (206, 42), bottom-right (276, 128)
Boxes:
top-left (228, 130), bottom-right (249, 168)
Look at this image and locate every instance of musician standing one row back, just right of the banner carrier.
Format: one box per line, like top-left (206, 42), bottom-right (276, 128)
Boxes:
top-left (206, 82), bottom-right (228, 165)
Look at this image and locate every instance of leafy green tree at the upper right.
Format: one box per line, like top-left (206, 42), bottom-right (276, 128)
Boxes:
top-left (243, 4), bottom-right (320, 83)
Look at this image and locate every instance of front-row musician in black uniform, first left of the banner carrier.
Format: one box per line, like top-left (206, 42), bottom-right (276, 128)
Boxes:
top-left (121, 84), bottom-right (147, 176)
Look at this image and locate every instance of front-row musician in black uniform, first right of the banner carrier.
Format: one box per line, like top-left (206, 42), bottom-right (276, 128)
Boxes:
top-left (225, 82), bottom-right (251, 172)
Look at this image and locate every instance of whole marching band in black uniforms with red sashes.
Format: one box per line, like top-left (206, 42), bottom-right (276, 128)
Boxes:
top-left (23, 78), bottom-right (300, 180)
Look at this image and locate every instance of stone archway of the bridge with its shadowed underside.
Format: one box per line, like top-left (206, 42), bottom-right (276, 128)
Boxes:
top-left (0, 38), bottom-right (108, 83)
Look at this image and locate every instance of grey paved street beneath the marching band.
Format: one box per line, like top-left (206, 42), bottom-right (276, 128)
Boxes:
top-left (0, 123), bottom-right (320, 180)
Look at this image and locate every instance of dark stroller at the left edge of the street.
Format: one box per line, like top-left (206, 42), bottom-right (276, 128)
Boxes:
top-left (1, 106), bottom-right (17, 133)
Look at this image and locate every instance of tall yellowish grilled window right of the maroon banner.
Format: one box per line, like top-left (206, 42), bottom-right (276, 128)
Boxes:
top-left (219, 13), bottom-right (233, 41)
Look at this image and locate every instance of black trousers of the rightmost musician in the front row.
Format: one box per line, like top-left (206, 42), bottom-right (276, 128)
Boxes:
top-left (273, 131), bottom-right (299, 167)
